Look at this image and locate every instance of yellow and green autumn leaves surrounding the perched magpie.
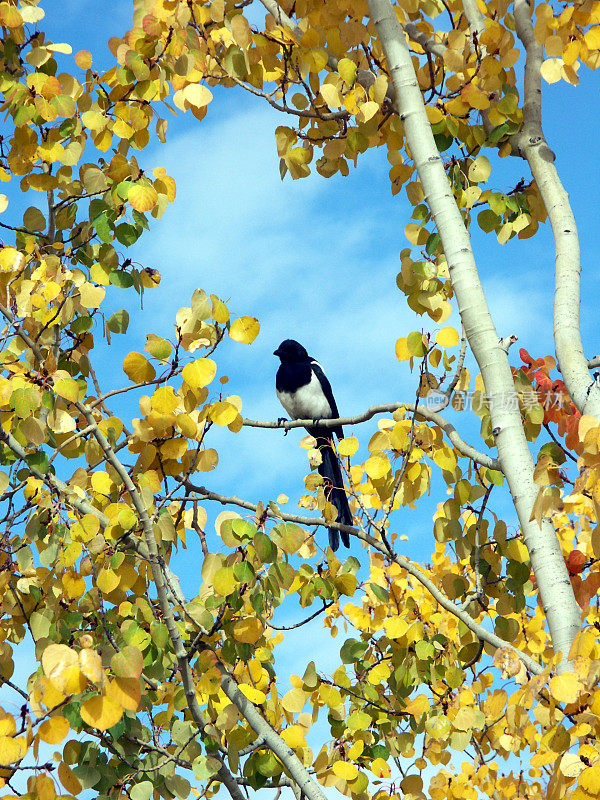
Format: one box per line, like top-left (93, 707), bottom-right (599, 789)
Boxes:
top-left (0, 0), bottom-right (600, 800)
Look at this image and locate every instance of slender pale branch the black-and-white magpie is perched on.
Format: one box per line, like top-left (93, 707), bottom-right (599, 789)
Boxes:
top-left (242, 403), bottom-right (502, 471)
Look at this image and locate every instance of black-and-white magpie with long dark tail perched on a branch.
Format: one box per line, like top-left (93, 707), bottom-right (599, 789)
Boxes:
top-left (273, 339), bottom-right (353, 550)
